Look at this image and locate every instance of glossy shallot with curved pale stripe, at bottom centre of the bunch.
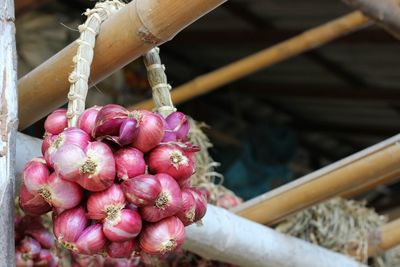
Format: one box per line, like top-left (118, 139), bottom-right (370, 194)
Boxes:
top-left (103, 209), bottom-right (142, 242)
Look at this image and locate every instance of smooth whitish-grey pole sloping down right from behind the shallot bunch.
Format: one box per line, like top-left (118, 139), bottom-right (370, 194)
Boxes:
top-left (184, 205), bottom-right (365, 267)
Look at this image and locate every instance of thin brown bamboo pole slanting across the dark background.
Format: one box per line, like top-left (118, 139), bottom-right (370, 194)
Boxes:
top-left (131, 11), bottom-right (370, 109)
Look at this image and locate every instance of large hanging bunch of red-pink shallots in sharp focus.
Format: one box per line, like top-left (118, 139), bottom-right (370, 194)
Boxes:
top-left (20, 105), bottom-right (207, 258)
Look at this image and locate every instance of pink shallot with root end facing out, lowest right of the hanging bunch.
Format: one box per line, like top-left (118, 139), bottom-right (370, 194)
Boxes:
top-left (139, 216), bottom-right (185, 255)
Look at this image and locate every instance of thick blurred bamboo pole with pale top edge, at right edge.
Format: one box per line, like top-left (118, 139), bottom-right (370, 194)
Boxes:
top-left (232, 134), bottom-right (400, 224)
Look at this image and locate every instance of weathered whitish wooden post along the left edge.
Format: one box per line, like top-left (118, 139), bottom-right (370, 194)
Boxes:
top-left (0, 0), bottom-right (18, 266)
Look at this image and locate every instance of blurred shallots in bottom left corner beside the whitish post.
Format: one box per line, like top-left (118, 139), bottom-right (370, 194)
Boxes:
top-left (14, 216), bottom-right (59, 267)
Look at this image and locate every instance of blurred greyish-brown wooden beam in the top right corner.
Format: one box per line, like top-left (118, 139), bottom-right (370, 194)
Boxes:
top-left (343, 0), bottom-right (400, 39)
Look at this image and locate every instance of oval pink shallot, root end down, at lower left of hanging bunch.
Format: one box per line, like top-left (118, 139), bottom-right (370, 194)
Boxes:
top-left (53, 207), bottom-right (88, 251)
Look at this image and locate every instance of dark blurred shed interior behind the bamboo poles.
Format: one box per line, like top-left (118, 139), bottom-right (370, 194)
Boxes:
top-left (15, 0), bottom-right (400, 218)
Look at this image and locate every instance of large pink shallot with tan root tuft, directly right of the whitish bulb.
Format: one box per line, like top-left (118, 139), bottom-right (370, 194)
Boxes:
top-left (77, 142), bottom-right (115, 192)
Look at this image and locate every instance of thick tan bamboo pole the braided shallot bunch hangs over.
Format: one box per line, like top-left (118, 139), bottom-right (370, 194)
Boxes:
top-left (18, 0), bottom-right (226, 129)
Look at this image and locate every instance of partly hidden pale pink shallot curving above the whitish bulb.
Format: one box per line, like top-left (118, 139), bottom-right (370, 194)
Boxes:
top-left (44, 127), bottom-right (90, 167)
